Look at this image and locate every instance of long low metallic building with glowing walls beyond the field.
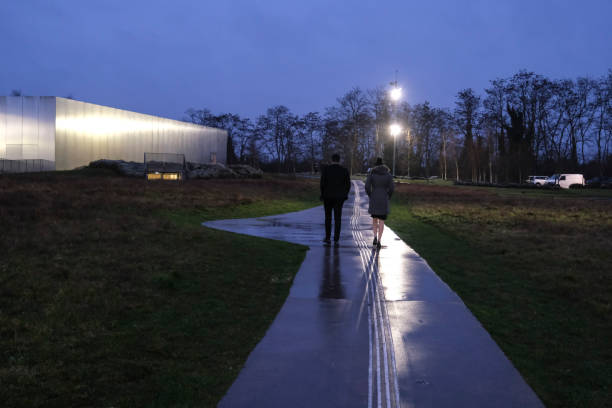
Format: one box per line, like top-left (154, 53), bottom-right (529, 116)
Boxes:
top-left (0, 96), bottom-right (227, 171)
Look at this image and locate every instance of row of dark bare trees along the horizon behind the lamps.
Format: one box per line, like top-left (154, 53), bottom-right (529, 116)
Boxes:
top-left (185, 70), bottom-right (612, 182)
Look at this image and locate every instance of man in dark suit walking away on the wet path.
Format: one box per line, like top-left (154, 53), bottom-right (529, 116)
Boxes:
top-left (321, 154), bottom-right (351, 244)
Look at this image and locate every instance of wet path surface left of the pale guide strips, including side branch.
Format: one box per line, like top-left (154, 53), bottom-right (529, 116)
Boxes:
top-left (204, 186), bottom-right (370, 408)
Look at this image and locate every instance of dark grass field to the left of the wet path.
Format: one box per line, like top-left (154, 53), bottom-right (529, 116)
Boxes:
top-left (0, 171), bottom-right (319, 407)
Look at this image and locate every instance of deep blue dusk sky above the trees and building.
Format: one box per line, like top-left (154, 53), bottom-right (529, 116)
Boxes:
top-left (0, 0), bottom-right (612, 119)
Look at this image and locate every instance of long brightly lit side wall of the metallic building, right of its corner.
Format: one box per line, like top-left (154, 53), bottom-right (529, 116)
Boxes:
top-left (55, 98), bottom-right (227, 170)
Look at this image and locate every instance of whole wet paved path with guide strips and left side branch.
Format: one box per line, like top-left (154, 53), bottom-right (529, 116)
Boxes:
top-left (204, 181), bottom-right (543, 408)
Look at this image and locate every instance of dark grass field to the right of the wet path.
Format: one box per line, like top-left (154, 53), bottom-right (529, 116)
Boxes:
top-left (388, 183), bottom-right (612, 407)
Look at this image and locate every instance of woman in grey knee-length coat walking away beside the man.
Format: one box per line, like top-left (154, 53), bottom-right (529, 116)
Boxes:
top-left (366, 157), bottom-right (394, 248)
